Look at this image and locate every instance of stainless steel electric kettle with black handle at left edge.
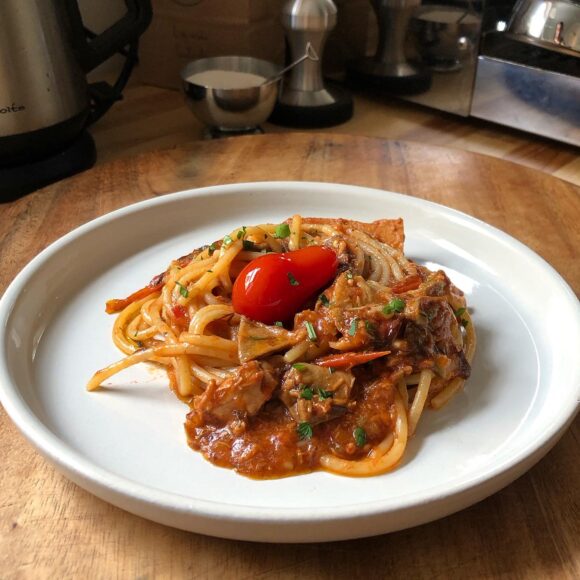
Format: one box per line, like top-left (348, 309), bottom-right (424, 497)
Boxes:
top-left (0, 0), bottom-right (151, 168)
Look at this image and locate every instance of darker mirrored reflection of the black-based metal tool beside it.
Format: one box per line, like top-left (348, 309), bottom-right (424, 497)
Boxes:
top-left (349, 0), bottom-right (431, 95)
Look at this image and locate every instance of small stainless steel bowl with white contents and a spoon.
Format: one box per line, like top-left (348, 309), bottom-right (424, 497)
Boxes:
top-left (181, 56), bottom-right (281, 133)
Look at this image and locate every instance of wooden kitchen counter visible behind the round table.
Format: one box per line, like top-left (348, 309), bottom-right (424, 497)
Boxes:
top-left (91, 85), bottom-right (580, 185)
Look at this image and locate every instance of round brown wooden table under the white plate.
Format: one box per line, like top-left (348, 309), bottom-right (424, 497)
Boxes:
top-left (0, 133), bottom-right (580, 579)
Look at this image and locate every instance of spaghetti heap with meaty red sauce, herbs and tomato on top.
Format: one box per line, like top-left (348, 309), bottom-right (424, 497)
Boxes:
top-left (87, 216), bottom-right (476, 478)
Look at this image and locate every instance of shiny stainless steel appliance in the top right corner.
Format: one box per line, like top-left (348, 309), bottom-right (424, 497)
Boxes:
top-left (371, 0), bottom-right (580, 146)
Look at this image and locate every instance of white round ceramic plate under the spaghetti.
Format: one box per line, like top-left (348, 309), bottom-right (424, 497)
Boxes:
top-left (0, 182), bottom-right (580, 542)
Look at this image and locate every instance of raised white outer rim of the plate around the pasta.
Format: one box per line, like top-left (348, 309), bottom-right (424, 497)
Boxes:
top-left (0, 181), bottom-right (580, 541)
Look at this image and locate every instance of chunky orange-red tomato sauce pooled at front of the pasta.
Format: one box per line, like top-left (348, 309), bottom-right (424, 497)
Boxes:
top-left (185, 382), bottom-right (395, 479)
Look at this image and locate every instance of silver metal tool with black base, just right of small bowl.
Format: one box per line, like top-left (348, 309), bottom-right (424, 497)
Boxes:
top-left (270, 0), bottom-right (353, 127)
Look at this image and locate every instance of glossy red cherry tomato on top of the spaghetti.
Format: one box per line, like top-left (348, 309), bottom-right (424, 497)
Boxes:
top-left (232, 246), bottom-right (338, 324)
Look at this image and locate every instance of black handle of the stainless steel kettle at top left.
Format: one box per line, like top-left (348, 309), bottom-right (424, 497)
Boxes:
top-left (64, 0), bottom-right (153, 72)
